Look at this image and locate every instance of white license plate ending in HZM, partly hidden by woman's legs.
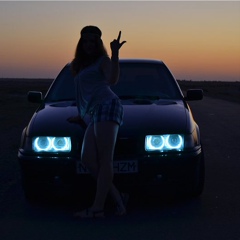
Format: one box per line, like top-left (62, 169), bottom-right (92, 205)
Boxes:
top-left (77, 160), bottom-right (138, 174)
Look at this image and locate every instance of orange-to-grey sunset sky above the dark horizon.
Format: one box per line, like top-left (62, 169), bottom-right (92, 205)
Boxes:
top-left (0, 1), bottom-right (240, 81)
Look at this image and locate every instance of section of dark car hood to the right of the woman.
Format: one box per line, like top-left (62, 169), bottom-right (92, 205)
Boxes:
top-left (121, 100), bottom-right (194, 135)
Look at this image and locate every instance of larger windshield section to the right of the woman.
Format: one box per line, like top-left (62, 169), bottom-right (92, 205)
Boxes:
top-left (112, 62), bottom-right (181, 99)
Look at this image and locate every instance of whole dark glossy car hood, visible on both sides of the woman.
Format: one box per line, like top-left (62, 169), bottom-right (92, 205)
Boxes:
top-left (28, 100), bottom-right (194, 137)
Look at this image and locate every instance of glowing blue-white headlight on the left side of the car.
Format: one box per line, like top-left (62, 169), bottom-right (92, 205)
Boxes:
top-left (32, 137), bottom-right (71, 152)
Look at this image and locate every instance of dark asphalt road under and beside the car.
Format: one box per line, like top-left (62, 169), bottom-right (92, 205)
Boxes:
top-left (0, 98), bottom-right (240, 240)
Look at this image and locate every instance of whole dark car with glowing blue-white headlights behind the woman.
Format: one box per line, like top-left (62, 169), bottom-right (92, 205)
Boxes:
top-left (18, 59), bottom-right (204, 202)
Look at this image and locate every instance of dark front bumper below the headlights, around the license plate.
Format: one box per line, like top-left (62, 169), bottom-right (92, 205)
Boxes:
top-left (18, 146), bottom-right (203, 195)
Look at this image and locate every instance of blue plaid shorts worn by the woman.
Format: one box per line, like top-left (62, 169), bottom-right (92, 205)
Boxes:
top-left (90, 99), bottom-right (123, 125)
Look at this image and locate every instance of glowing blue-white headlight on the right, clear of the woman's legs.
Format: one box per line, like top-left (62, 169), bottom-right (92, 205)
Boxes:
top-left (145, 134), bottom-right (184, 152)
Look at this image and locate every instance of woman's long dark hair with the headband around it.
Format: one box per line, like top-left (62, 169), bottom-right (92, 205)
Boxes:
top-left (71, 26), bottom-right (108, 75)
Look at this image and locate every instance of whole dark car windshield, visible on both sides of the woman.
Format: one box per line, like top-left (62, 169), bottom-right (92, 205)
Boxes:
top-left (45, 62), bottom-right (182, 102)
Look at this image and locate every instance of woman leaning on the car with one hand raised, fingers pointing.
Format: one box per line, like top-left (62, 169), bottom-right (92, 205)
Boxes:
top-left (69, 26), bottom-right (126, 218)
